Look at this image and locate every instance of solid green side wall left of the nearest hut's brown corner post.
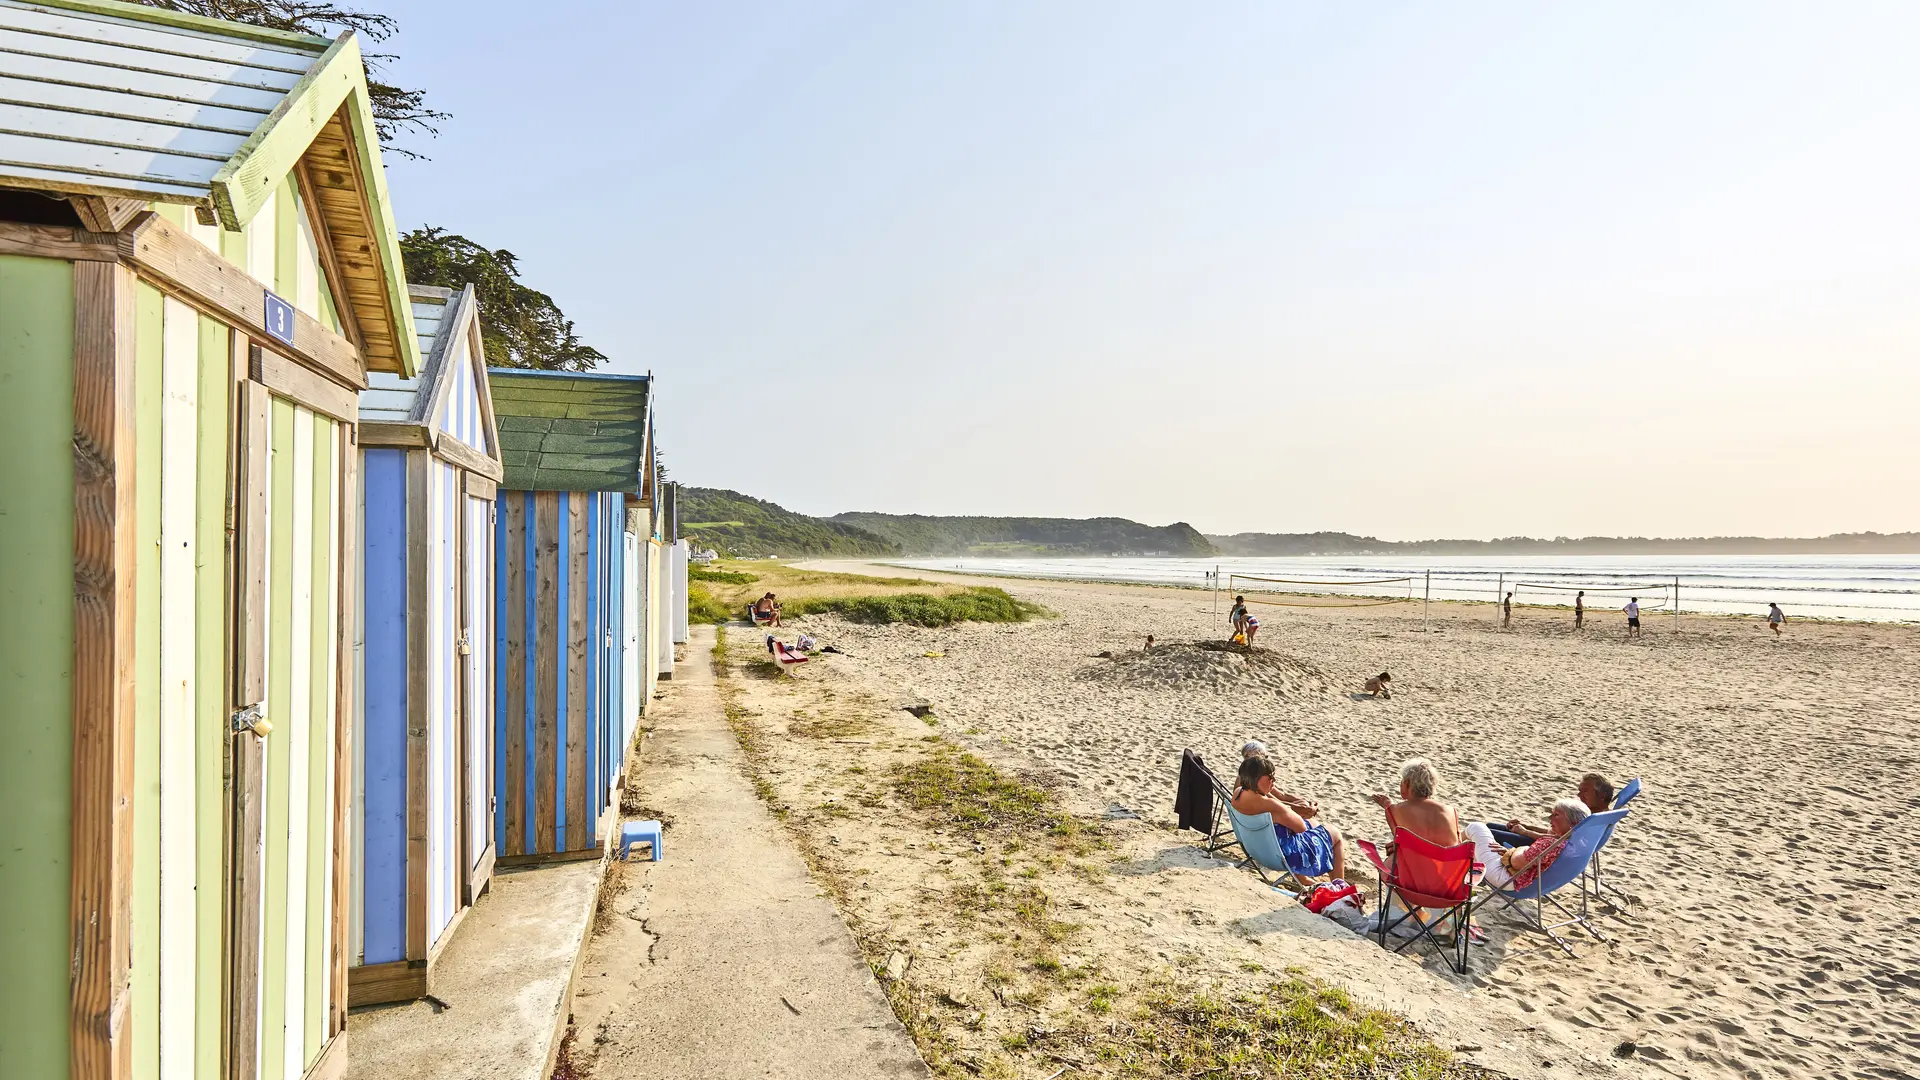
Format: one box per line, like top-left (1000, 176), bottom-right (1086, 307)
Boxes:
top-left (0, 256), bottom-right (73, 1076)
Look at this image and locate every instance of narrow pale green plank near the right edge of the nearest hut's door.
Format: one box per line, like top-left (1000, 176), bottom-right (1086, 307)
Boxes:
top-left (303, 417), bottom-right (340, 1068)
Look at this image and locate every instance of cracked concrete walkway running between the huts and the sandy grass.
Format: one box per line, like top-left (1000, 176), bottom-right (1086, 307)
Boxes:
top-left (572, 626), bottom-right (927, 1080)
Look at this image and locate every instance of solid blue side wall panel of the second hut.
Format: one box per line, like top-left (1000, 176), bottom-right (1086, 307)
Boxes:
top-left (361, 450), bottom-right (407, 963)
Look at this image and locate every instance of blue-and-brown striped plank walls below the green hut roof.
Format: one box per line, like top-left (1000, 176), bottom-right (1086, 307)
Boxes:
top-left (493, 490), bottom-right (632, 865)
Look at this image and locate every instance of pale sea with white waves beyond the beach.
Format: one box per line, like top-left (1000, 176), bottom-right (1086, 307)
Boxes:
top-left (893, 553), bottom-right (1920, 623)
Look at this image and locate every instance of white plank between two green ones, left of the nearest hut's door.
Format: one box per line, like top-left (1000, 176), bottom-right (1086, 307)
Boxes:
top-left (157, 296), bottom-right (200, 1080)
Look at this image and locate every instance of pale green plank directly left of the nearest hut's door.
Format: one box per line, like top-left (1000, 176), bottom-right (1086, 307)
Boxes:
top-left (194, 315), bottom-right (232, 1080)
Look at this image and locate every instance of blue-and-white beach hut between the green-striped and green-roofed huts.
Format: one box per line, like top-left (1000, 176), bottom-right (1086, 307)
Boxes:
top-left (348, 284), bottom-right (501, 1005)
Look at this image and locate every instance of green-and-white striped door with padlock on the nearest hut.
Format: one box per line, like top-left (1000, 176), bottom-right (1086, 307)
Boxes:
top-left (225, 346), bottom-right (359, 1080)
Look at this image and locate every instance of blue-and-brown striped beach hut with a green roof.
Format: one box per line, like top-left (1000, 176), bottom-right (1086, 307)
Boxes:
top-left (490, 369), bottom-right (653, 867)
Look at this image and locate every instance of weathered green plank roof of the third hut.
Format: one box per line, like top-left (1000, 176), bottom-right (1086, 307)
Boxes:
top-left (488, 367), bottom-right (653, 494)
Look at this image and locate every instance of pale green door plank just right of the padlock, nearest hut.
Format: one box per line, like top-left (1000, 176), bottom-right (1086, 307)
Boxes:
top-left (259, 398), bottom-right (300, 1080)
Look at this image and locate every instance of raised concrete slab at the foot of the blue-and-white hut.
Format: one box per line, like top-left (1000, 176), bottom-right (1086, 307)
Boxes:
top-left (348, 859), bottom-right (601, 1080)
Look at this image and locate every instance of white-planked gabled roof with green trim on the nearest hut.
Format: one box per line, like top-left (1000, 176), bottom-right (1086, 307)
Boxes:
top-left (0, 0), bottom-right (419, 375)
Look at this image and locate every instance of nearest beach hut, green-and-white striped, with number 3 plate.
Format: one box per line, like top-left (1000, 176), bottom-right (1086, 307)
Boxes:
top-left (0, 0), bottom-right (417, 1080)
